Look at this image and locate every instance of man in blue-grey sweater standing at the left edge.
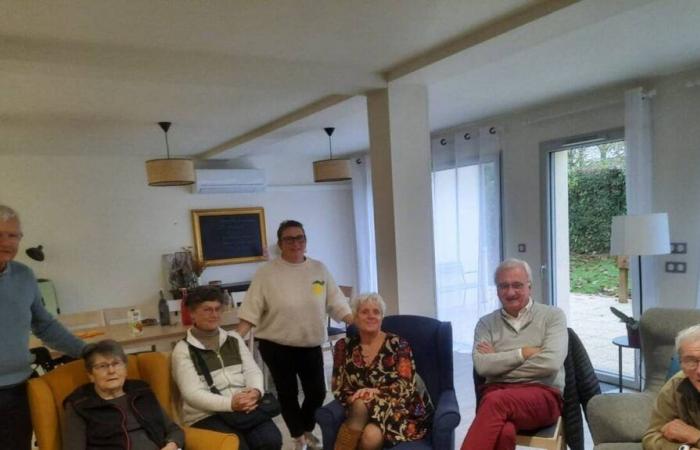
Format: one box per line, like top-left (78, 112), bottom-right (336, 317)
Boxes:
top-left (0, 205), bottom-right (84, 450)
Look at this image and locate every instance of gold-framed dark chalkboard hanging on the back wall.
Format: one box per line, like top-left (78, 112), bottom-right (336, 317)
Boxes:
top-left (192, 208), bottom-right (267, 266)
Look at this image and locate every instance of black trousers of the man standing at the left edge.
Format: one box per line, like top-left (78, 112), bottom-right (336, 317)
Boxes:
top-left (0, 383), bottom-right (32, 450)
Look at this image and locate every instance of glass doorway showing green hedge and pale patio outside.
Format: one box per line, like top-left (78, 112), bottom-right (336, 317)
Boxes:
top-left (541, 129), bottom-right (639, 388)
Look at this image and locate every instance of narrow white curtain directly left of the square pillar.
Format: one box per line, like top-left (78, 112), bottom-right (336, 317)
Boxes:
top-left (352, 155), bottom-right (377, 294)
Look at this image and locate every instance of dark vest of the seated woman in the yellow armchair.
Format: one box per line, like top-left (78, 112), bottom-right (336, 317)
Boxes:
top-left (64, 380), bottom-right (166, 450)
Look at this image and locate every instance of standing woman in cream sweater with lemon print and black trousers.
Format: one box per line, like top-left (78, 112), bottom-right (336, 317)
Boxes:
top-left (237, 220), bottom-right (352, 449)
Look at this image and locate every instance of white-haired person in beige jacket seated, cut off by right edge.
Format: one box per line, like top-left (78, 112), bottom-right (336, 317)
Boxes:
top-left (642, 325), bottom-right (700, 450)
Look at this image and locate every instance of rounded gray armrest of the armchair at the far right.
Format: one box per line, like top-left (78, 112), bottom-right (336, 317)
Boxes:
top-left (586, 392), bottom-right (656, 445)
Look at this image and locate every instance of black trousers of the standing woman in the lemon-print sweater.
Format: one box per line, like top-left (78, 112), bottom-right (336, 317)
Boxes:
top-left (258, 339), bottom-right (326, 438)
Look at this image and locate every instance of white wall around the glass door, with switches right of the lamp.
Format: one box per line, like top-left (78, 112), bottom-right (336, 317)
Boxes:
top-left (456, 65), bottom-right (700, 308)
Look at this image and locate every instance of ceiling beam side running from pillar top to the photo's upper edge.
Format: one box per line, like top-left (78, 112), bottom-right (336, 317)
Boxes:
top-left (382, 0), bottom-right (581, 82)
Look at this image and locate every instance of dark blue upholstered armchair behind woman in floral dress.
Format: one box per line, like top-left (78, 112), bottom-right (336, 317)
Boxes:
top-left (316, 315), bottom-right (460, 450)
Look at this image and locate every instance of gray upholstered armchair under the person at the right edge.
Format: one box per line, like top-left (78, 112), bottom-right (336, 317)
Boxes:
top-left (587, 308), bottom-right (700, 450)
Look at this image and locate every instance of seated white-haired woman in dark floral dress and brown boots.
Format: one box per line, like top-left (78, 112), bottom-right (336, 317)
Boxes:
top-left (333, 294), bottom-right (433, 450)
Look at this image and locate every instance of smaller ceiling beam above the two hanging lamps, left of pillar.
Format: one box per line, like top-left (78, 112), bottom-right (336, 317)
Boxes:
top-left (194, 94), bottom-right (353, 159)
